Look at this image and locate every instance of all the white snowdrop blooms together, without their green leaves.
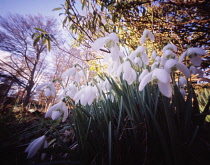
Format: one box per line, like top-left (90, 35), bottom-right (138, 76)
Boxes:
top-left (29, 29), bottom-right (205, 158)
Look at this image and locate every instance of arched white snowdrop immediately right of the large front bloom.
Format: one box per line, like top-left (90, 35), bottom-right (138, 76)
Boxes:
top-left (164, 59), bottom-right (190, 78)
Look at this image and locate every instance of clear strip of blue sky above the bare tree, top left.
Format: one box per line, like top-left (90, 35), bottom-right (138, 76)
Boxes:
top-left (0, 0), bottom-right (65, 18)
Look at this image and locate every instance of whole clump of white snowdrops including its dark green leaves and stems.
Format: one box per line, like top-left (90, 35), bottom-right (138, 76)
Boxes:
top-left (26, 29), bottom-right (206, 164)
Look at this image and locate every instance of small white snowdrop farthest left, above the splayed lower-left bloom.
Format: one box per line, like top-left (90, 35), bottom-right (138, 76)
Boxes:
top-left (36, 82), bottom-right (56, 97)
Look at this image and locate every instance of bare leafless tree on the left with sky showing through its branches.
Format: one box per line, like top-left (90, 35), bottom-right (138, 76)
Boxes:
top-left (0, 14), bottom-right (57, 105)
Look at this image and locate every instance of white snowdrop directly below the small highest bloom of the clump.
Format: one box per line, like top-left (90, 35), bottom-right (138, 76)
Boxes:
top-left (128, 46), bottom-right (149, 67)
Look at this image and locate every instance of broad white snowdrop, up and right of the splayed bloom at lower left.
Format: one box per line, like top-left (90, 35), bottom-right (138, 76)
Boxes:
top-left (73, 86), bottom-right (97, 106)
